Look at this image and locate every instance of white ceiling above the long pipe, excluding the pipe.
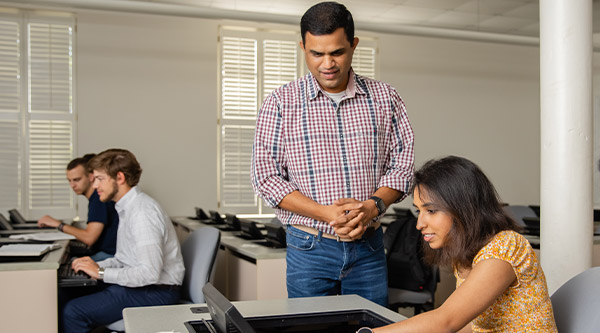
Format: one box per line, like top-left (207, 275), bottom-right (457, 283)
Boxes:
top-left (135, 0), bottom-right (600, 37)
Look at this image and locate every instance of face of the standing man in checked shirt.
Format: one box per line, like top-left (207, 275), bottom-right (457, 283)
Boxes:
top-left (300, 28), bottom-right (358, 93)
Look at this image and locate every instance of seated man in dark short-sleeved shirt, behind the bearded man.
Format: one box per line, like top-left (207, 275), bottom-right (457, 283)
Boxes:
top-left (38, 154), bottom-right (119, 261)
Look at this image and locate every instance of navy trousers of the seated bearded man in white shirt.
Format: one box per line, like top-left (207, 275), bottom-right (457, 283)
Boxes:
top-left (62, 284), bottom-right (180, 333)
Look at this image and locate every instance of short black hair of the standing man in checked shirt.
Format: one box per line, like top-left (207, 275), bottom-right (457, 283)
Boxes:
top-left (300, 1), bottom-right (354, 45)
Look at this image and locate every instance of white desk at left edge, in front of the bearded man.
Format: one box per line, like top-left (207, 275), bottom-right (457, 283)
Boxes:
top-left (0, 240), bottom-right (69, 333)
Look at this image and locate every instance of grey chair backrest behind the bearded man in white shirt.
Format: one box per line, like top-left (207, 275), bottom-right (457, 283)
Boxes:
top-left (181, 227), bottom-right (221, 303)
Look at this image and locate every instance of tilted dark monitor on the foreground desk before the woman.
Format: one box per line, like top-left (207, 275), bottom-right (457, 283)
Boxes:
top-left (202, 282), bottom-right (255, 333)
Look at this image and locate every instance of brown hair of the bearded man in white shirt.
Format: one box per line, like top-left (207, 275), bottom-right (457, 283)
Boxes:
top-left (89, 148), bottom-right (142, 187)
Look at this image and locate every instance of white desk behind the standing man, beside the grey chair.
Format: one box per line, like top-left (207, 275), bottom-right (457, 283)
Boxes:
top-left (171, 217), bottom-right (287, 301)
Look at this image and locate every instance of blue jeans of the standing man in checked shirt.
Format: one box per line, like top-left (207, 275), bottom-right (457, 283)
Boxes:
top-left (286, 225), bottom-right (388, 306)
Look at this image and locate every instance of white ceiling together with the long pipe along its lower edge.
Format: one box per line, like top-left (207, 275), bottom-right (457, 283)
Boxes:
top-left (7, 0), bottom-right (600, 42)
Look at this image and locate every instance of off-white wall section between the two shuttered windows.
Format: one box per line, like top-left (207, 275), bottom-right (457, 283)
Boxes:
top-left (76, 12), bottom-right (217, 216)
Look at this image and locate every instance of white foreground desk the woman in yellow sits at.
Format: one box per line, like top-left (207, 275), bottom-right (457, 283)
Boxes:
top-left (123, 295), bottom-right (406, 333)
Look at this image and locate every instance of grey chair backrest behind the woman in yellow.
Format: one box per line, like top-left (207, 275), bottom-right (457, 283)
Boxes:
top-left (550, 267), bottom-right (600, 333)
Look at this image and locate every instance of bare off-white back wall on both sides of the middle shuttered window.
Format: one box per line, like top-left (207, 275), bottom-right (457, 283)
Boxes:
top-left (70, 12), bottom-right (592, 215)
